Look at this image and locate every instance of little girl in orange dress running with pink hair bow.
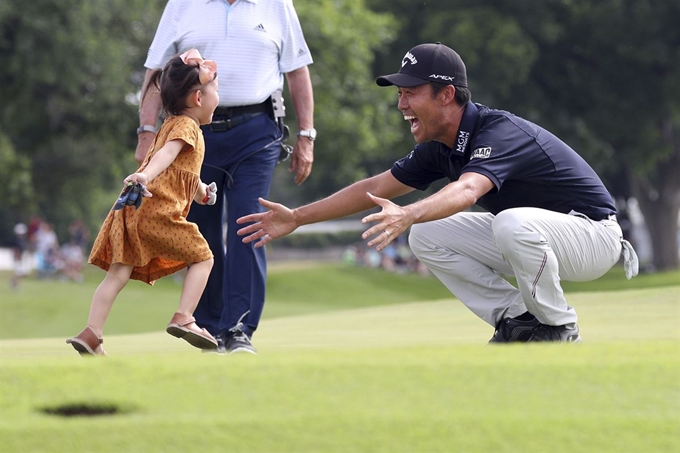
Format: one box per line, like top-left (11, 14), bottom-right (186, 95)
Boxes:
top-left (66, 49), bottom-right (219, 355)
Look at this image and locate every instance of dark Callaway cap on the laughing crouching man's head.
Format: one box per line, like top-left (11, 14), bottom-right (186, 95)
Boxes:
top-left (375, 42), bottom-right (467, 87)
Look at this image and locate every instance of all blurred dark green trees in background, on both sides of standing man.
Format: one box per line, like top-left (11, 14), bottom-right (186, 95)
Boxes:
top-left (0, 0), bottom-right (680, 270)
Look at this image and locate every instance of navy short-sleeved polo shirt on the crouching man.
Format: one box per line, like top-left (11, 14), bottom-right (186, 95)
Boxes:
top-left (391, 102), bottom-right (616, 220)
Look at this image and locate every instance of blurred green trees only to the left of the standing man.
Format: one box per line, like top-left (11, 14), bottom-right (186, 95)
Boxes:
top-left (0, 0), bottom-right (165, 244)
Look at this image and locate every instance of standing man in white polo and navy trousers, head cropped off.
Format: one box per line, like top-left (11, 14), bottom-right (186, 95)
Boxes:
top-left (135, 0), bottom-right (316, 353)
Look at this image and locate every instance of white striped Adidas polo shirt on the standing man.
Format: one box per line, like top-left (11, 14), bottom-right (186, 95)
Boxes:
top-left (144, 0), bottom-right (312, 107)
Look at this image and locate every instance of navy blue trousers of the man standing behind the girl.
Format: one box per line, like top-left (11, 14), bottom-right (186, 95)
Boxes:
top-left (187, 114), bottom-right (281, 336)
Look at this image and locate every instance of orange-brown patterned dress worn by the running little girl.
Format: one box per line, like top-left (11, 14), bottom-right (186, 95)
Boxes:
top-left (89, 115), bottom-right (213, 285)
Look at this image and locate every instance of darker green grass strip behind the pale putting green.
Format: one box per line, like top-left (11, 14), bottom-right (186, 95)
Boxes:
top-left (0, 263), bottom-right (680, 339)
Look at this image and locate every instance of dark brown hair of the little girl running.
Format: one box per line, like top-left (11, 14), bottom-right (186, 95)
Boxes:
top-left (142, 57), bottom-right (206, 117)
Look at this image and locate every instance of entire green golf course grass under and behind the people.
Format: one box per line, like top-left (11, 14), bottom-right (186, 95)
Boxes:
top-left (0, 265), bottom-right (680, 453)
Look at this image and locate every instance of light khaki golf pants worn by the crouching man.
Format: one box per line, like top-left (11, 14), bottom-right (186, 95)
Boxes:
top-left (409, 208), bottom-right (623, 326)
